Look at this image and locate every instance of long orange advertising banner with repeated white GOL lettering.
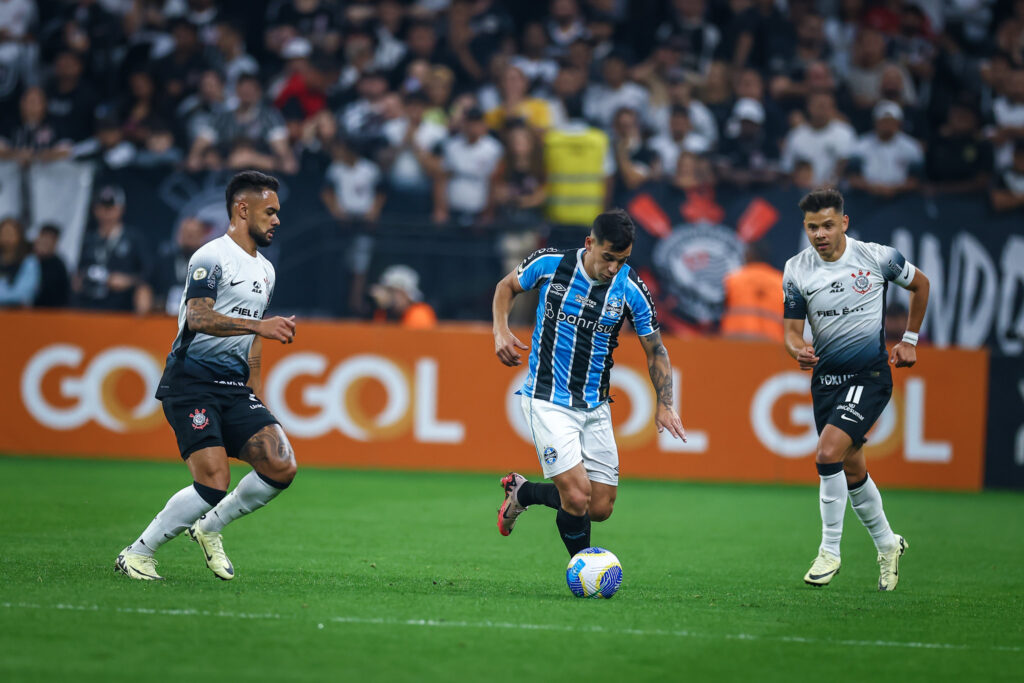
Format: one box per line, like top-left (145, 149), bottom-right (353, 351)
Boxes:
top-left (0, 311), bottom-right (988, 489)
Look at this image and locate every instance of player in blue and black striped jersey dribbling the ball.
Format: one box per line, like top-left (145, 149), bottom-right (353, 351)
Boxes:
top-left (494, 209), bottom-right (686, 555)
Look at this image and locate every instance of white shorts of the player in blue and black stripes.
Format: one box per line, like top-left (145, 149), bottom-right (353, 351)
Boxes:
top-left (521, 395), bottom-right (618, 486)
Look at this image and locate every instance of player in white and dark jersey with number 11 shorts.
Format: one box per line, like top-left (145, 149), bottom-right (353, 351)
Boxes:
top-left (782, 188), bottom-right (929, 591)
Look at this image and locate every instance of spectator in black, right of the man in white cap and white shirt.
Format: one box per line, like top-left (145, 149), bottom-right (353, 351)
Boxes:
top-left (925, 101), bottom-right (993, 193)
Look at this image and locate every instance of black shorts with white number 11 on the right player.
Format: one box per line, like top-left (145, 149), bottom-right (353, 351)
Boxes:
top-left (811, 368), bottom-right (893, 446)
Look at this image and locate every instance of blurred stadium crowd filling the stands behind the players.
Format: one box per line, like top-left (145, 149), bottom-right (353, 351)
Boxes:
top-left (0, 0), bottom-right (1024, 329)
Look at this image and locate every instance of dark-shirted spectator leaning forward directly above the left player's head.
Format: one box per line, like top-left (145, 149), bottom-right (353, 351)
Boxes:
top-left (187, 75), bottom-right (298, 173)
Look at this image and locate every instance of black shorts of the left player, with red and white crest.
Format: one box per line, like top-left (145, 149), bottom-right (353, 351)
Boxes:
top-left (162, 391), bottom-right (278, 460)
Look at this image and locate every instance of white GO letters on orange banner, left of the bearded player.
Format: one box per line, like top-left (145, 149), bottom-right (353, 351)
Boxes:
top-left (20, 344), bottom-right (162, 432)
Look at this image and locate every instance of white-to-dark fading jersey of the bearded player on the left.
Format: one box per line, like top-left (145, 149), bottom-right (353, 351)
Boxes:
top-left (157, 234), bottom-right (274, 398)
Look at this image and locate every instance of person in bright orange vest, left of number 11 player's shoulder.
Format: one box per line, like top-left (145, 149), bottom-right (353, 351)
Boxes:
top-left (720, 243), bottom-right (782, 342)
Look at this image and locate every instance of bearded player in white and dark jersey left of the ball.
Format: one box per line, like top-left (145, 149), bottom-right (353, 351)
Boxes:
top-left (115, 171), bottom-right (295, 581)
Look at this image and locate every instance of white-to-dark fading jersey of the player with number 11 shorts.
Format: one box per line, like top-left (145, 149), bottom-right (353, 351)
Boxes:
top-left (782, 237), bottom-right (914, 375)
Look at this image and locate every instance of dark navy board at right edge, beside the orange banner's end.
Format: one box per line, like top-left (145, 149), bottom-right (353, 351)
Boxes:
top-left (985, 356), bottom-right (1024, 488)
